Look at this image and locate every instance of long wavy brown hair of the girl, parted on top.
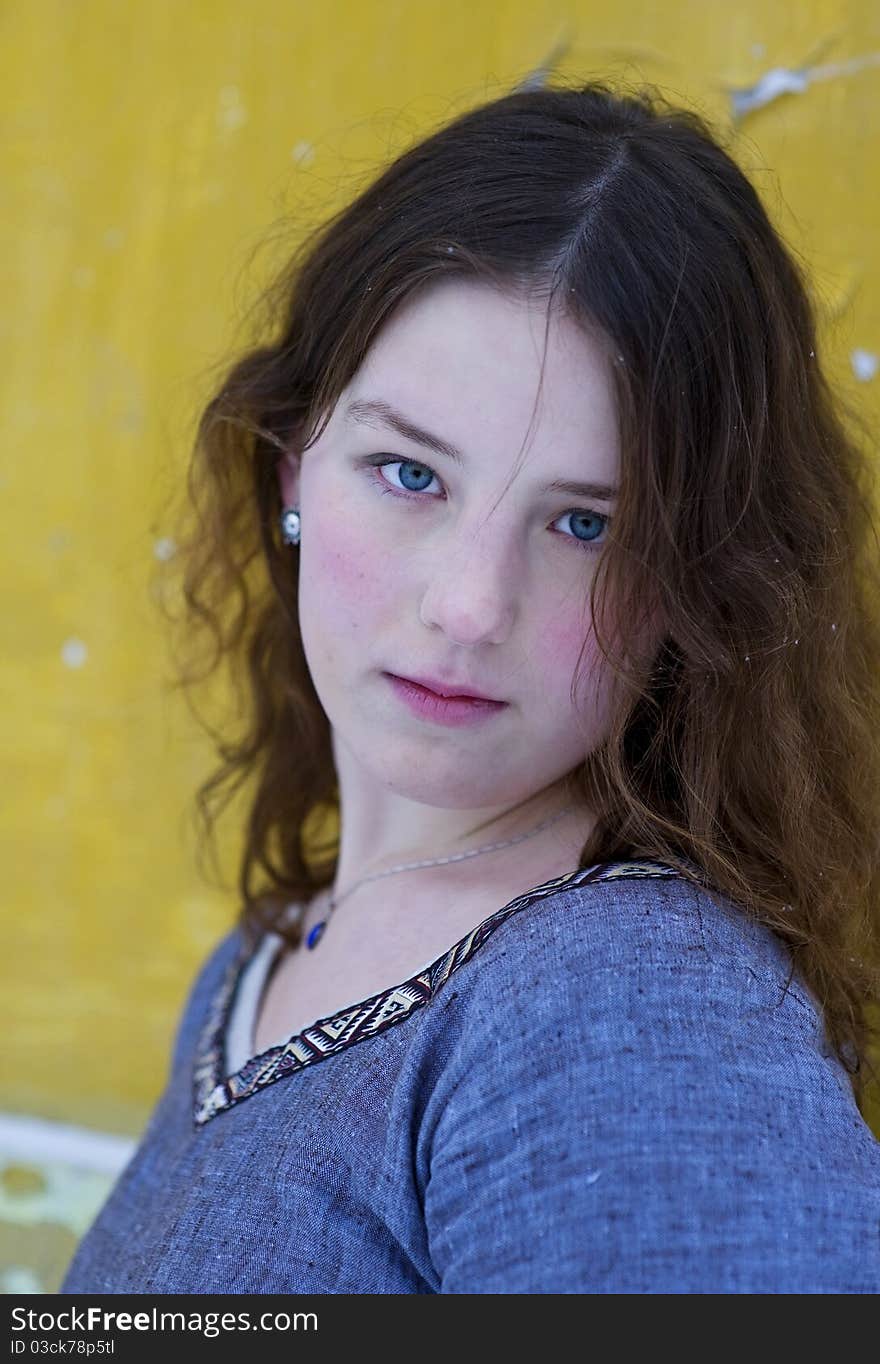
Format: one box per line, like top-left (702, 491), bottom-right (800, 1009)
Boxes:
top-left (154, 82), bottom-right (880, 1105)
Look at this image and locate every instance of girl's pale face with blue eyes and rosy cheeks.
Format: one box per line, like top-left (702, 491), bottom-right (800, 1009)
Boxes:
top-left (278, 280), bottom-right (619, 810)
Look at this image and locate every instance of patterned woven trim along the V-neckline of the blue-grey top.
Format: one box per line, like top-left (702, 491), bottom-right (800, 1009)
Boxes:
top-left (192, 859), bottom-right (681, 1127)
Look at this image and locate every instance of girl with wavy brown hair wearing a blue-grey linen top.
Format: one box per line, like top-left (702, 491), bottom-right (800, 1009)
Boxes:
top-left (61, 83), bottom-right (880, 1294)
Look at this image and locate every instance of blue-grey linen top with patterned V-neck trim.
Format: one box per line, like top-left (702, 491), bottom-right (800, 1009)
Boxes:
top-left (60, 861), bottom-right (880, 1294)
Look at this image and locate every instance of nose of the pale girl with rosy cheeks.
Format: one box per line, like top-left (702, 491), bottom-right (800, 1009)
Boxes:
top-left (420, 525), bottom-right (521, 645)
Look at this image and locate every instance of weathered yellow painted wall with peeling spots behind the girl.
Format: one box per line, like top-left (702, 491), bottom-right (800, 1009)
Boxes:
top-left (0, 0), bottom-right (880, 1292)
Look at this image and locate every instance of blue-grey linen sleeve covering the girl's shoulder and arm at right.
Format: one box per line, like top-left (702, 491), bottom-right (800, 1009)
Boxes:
top-left (420, 856), bottom-right (880, 1292)
